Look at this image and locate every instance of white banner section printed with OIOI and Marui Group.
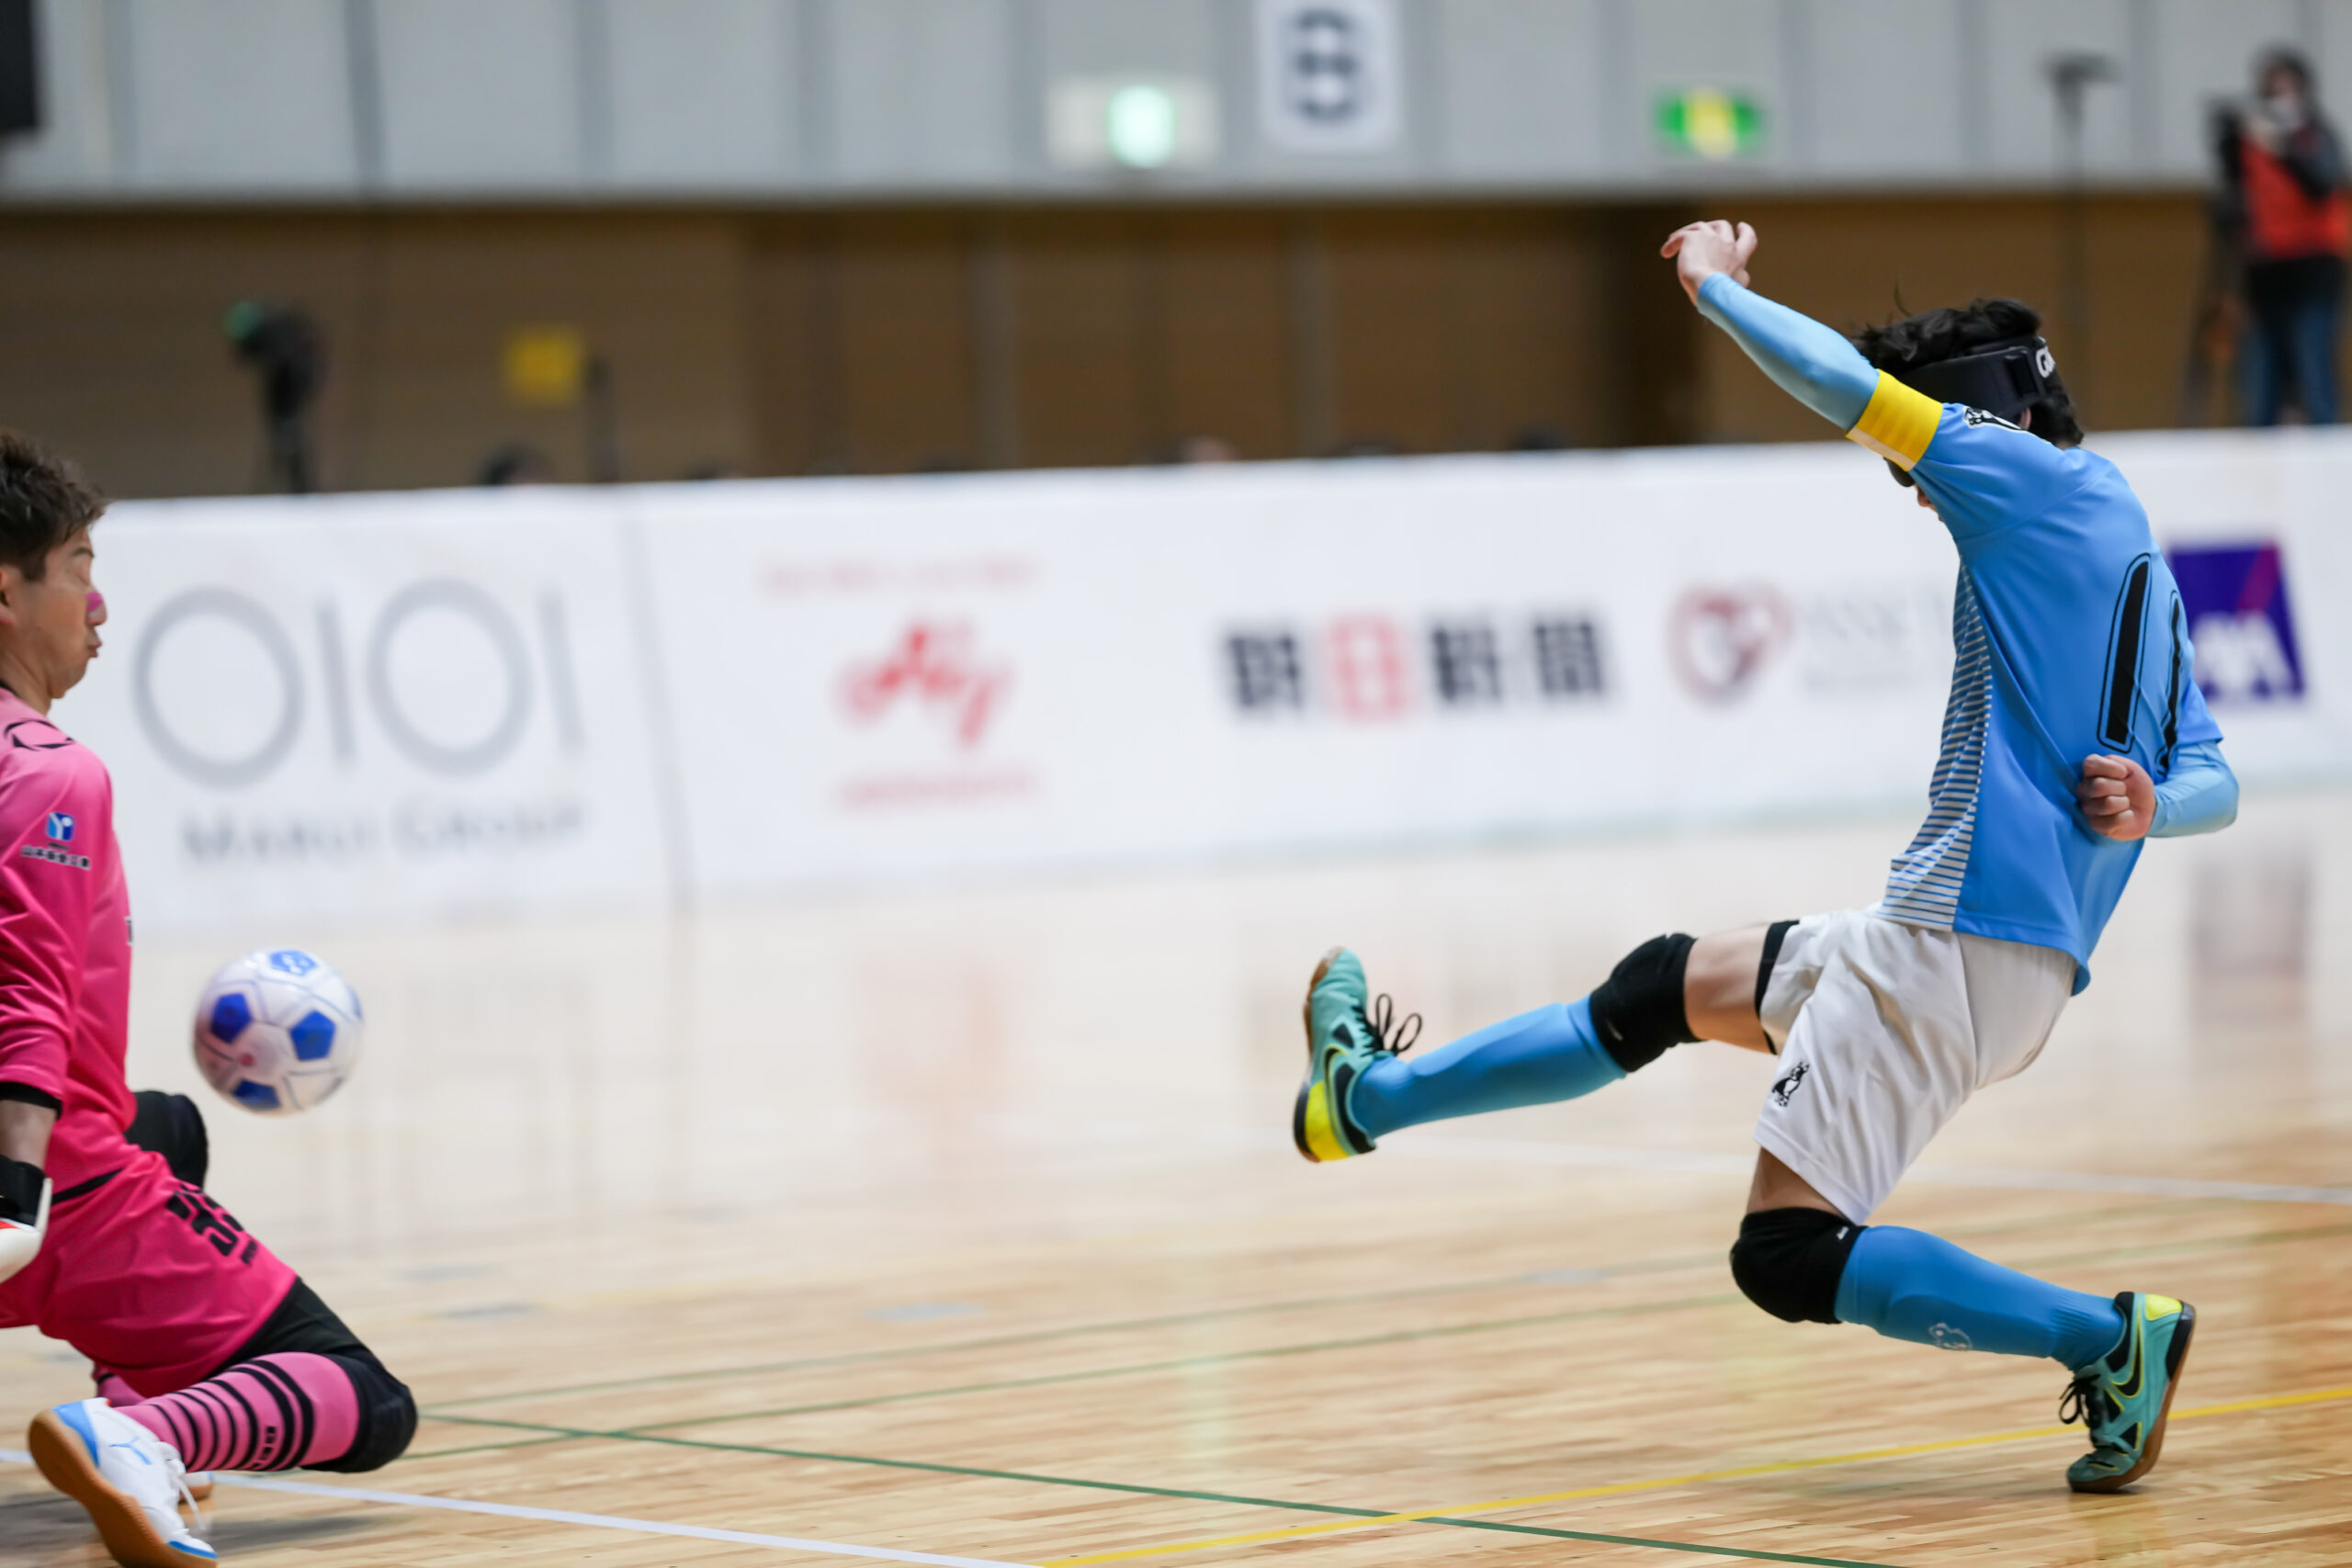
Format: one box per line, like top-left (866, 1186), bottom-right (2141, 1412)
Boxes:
top-left (56, 491), bottom-right (671, 926)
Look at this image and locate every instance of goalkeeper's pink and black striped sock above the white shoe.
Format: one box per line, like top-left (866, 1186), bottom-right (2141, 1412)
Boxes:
top-left (122, 1352), bottom-right (360, 1470)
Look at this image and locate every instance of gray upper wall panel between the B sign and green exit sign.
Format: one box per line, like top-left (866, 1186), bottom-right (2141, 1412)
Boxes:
top-left (1437, 0), bottom-right (1609, 181)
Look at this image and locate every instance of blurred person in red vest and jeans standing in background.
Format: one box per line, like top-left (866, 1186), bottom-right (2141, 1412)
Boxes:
top-left (2221, 50), bottom-right (2352, 425)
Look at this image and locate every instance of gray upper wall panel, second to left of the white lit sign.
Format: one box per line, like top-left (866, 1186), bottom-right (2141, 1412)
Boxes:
top-left (605, 0), bottom-right (802, 188)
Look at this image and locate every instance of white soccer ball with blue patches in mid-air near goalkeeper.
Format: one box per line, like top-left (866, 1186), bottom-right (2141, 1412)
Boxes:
top-left (195, 947), bottom-right (365, 1117)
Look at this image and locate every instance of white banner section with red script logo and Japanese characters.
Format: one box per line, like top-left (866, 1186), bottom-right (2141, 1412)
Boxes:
top-left (647, 454), bottom-right (1950, 888)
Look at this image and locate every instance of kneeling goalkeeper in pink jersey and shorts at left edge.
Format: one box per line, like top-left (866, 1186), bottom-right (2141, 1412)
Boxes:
top-left (0, 430), bottom-right (416, 1568)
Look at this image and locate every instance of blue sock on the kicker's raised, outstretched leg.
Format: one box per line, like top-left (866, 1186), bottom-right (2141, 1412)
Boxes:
top-left (1348, 997), bottom-right (1625, 1138)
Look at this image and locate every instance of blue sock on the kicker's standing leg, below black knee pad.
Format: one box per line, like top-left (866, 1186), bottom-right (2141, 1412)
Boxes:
top-left (1837, 1224), bottom-right (2124, 1371)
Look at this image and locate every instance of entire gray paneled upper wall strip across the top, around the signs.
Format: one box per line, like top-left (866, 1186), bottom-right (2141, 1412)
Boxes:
top-left (0, 0), bottom-right (2295, 197)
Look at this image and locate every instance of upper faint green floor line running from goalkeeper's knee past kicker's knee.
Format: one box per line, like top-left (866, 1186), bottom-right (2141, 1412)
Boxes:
top-left (418, 1199), bottom-right (2182, 1411)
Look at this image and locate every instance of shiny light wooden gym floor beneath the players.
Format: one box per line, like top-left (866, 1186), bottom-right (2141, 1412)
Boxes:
top-left (0, 795), bottom-right (2352, 1568)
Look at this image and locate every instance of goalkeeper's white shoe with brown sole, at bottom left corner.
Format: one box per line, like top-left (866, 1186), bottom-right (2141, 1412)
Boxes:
top-left (28, 1399), bottom-right (217, 1568)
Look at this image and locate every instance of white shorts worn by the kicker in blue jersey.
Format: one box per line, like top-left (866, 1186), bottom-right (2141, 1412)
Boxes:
top-left (1757, 909), bottom-right (2075, 1224)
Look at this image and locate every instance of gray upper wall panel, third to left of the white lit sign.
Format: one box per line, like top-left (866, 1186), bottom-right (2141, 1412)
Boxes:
top-left (380, 0), bottom-right (585, 190)
